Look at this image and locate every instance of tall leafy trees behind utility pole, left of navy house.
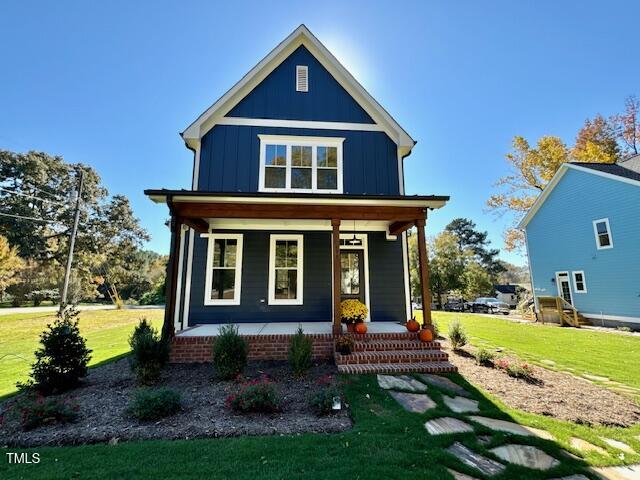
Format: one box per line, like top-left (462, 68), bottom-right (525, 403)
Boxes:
top-left (0, 150), bottom-right (167, 305)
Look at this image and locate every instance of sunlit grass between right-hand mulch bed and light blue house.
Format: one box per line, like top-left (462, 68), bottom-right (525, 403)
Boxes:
top-left (422, 312), bottom-right (640, 396)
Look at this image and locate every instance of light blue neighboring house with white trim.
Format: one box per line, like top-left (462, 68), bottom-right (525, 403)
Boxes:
top-left (519, 155), bottom-right (640, 328)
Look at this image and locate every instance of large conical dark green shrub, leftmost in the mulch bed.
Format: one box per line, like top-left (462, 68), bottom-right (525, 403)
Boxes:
top-left (18, 306), bottom-right (91, 395)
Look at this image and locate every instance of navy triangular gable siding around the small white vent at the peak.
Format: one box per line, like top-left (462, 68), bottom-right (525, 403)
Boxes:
top-left (227, 46), bottom-right (374, 124)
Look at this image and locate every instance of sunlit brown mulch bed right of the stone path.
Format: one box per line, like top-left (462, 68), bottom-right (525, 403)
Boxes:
top-left (449, 347), bottom-right (640, 427)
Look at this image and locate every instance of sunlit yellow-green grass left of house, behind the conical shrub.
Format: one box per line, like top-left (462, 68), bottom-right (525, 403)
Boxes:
top-left (0, 310), bottom-right (164, 397)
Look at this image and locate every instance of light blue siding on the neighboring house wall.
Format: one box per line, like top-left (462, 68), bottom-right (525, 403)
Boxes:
top-left (526, 169), bottom-right (640, 318)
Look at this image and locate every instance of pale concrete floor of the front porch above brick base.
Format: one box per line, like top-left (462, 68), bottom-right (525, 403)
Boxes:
top-left (176, 322), bottom-right (407, 337)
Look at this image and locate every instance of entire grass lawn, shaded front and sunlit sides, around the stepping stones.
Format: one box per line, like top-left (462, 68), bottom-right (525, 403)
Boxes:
top-left (0, 310), bottom-right (640, 480)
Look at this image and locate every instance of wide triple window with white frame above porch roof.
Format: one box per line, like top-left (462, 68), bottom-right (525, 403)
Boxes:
top-left (259, 135), bottom-right (344, 193)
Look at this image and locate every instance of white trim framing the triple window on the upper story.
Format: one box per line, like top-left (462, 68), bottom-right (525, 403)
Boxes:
top-left (258, 134), bottom-right (345, 194)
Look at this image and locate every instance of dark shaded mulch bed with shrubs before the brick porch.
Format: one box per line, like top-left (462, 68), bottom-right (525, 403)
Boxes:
top-left (0, 359), bottom-right (352, 447)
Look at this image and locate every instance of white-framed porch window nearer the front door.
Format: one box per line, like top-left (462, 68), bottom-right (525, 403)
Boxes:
top-left (269, 235), bottom-right (303, 305)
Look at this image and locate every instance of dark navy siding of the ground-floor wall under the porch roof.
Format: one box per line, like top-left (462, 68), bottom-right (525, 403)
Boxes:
top-left (185, 230), bottom-right (406, 328)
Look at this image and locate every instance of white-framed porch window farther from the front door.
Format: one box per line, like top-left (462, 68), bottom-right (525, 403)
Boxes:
top-left (203, 233), bottom-right (242, 305)
